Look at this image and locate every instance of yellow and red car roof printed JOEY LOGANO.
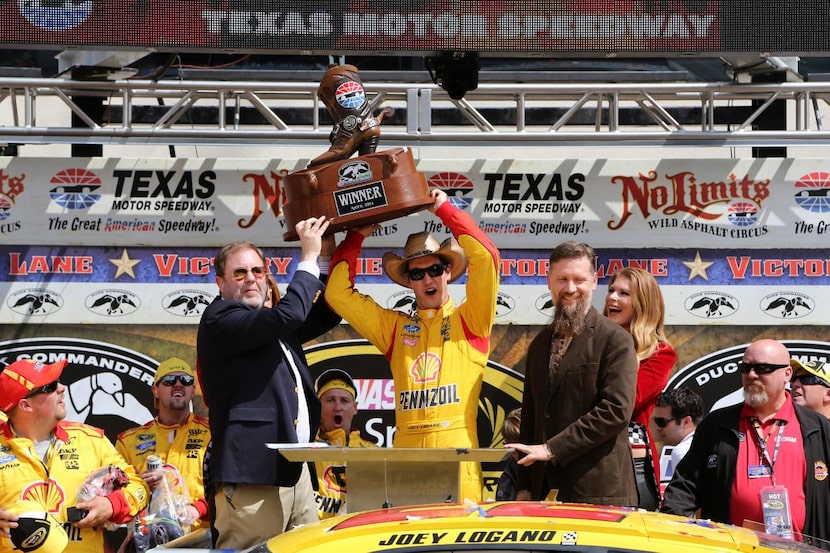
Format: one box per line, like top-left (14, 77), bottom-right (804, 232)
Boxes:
top-left (254, 502), bottom-right (820, 553)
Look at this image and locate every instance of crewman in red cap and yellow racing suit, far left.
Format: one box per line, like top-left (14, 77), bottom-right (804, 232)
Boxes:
top-left (0, 359), bottom-right (149, 553)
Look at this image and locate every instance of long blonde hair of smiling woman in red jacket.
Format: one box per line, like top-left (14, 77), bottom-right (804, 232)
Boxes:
top-left (602, 267), bottom-right (670, 361)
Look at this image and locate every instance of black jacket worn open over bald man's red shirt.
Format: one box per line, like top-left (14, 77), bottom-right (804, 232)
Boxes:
top-left (661, 403), bottom-right (830, 548)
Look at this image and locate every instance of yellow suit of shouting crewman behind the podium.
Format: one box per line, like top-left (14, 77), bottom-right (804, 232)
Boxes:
top-left (314, 428), bottom-right (377, 520)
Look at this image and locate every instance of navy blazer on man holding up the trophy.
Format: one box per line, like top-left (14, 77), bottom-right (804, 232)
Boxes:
top-left (196, 271), bottom-right (340, 486)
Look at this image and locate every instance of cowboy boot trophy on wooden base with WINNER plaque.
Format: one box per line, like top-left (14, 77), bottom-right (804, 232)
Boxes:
top-left (283, 65), bottom-right (434, 241)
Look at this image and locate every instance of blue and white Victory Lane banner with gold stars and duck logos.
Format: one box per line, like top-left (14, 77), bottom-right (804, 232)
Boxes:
top-left (0, 245), bottom-right (830, 326)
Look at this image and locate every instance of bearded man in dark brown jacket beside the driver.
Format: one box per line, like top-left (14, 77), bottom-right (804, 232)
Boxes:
top-left (505, 242), bottom-right (638, 505)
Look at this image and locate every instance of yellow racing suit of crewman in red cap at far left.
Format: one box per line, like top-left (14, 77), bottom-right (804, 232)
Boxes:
top-left (0, 421), bottom-right (149, 553)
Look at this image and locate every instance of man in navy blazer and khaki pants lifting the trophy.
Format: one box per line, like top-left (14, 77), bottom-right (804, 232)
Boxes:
top-left (196, 217), bottom-right (340, 549)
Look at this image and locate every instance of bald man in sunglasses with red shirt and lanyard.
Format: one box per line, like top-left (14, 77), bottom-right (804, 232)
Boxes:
top-left (661, 339), bottom-right (830, 540)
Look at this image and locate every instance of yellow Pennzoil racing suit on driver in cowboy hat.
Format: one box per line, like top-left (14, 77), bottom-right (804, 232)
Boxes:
top-left (326, 202), bottom-right (499, 501)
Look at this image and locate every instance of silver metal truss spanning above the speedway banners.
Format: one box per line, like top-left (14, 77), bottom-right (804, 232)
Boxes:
top-left (0, 78), bottom-right (830, 147)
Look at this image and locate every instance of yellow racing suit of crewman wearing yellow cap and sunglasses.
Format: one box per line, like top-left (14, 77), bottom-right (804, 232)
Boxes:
top-left (115, 413), bottom-right (210, 530)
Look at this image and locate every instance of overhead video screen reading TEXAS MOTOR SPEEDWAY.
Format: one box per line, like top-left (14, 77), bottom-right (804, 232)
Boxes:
top-left (0, 0), bottom-right (830, 56)
